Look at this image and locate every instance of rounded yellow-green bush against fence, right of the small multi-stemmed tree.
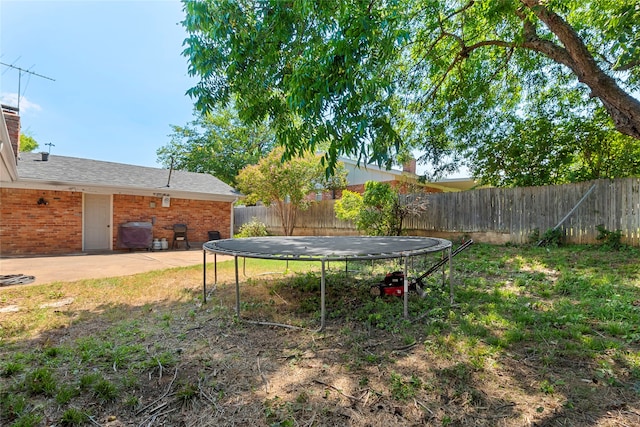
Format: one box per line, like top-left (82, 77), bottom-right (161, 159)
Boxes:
top-left (334, 181), bottom-right (427, 236)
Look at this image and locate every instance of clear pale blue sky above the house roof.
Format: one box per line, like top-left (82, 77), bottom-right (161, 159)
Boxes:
top-left (0, 0), bottom-right (195, 167)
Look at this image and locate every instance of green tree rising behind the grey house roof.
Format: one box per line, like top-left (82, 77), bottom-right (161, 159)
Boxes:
top-left (157, 105), bottom-right (275, 187)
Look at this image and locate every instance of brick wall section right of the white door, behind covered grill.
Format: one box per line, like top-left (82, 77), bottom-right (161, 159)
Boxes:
top-left (113, 195), bottom-right (231, 249)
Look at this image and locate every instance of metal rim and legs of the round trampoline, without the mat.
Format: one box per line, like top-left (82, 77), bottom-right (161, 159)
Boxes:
top-left (202, 236), bottom-right (454, 331)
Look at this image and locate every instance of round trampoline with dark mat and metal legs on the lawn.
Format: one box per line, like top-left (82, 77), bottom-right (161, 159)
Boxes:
top-left (202, 236), bottom-right (453, 331)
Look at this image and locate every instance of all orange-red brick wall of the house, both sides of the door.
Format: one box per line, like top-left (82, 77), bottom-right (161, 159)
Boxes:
top-left (0, 188), bottom-right (231, 256)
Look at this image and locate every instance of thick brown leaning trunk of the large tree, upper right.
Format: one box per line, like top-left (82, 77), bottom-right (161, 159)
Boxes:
top-left (521, 0), bottom-right (640, 139)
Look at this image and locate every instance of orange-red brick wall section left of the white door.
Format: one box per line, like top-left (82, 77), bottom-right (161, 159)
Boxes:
top-left (0, 188), bottom-right (82, 255)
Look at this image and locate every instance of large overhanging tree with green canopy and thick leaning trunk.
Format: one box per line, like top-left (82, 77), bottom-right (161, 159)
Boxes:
top-left (184, 0), bottom-right (640, 176)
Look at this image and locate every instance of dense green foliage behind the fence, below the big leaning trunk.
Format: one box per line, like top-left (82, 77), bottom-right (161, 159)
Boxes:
top-left (469, 108), bottom-right (640, 187)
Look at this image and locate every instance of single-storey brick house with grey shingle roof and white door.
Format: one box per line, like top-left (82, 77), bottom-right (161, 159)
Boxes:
top-left (0, 106), bottom-right (240, 256)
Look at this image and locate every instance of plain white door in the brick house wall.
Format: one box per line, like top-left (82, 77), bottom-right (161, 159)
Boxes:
top-left (84, 194), bottom-right (111, 251)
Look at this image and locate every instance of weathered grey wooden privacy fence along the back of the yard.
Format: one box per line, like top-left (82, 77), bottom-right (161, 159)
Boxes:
top-left (234, 178), bottom-right (640, 246)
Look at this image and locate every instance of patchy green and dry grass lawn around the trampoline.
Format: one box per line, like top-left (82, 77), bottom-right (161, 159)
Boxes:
top-left (0, 244), bottom-right (640, 425)
